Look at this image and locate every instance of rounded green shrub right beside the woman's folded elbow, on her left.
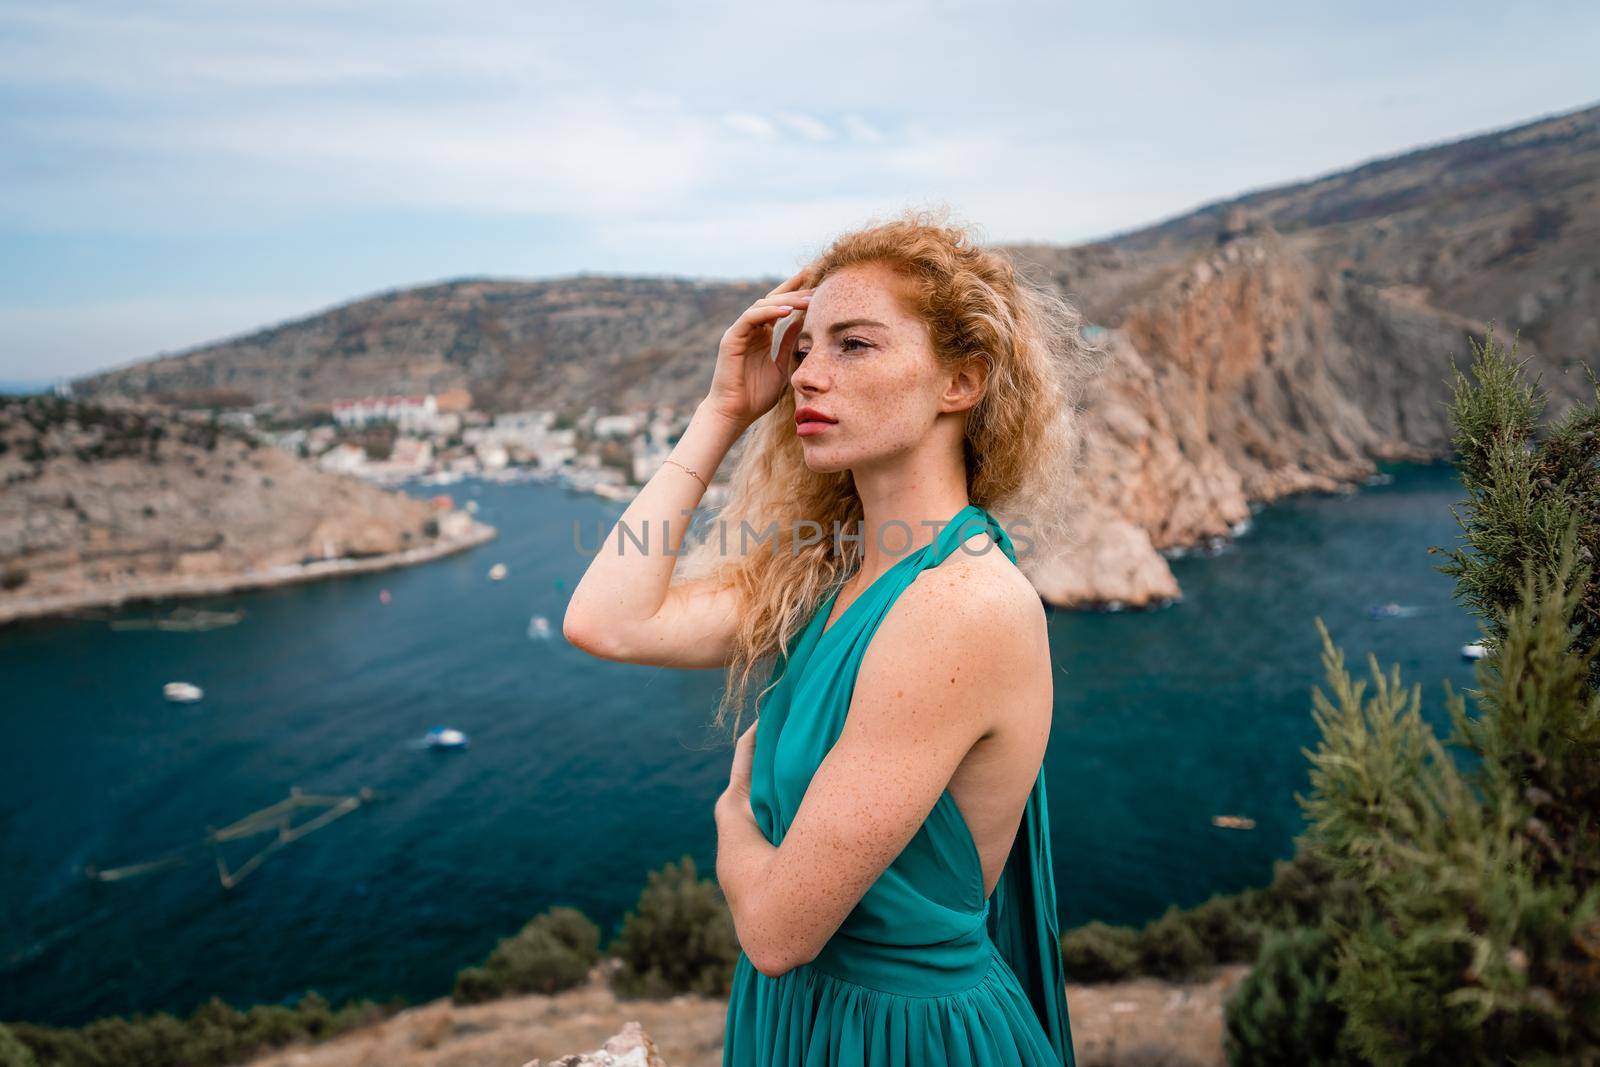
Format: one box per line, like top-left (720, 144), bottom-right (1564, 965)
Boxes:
top-left (608, 854), bottom-right (739, 997)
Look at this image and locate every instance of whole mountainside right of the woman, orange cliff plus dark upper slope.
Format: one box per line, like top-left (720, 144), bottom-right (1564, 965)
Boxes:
top-left (1013, 107), bottom-right (1600, 605)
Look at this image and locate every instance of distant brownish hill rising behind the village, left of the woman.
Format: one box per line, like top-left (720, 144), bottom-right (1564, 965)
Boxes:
top-left (72, 277), bottom-right (771, 413)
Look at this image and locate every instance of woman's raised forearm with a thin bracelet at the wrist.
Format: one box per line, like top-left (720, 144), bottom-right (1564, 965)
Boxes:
top-left (566, 402), bottom-right (744, 632)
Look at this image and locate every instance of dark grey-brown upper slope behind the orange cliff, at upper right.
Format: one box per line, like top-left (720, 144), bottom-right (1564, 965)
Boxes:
top-left (1081, 99), bottom-right (1600, 362)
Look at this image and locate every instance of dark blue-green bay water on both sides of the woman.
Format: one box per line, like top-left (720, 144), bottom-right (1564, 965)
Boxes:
top-left (0, 466), bottom-right (1478, 1024)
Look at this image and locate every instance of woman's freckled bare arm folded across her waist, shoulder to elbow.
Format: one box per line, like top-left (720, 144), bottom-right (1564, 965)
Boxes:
top-left (717, 566), bottom-right (1040, 977)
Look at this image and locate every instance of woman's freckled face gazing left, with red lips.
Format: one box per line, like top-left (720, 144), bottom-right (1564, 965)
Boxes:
top-left (789, 264), bottom-right (949, 472)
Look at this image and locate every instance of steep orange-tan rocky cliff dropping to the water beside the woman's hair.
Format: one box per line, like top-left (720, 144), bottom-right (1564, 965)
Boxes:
top-left (1030, 229), bottom-right (1536, 605)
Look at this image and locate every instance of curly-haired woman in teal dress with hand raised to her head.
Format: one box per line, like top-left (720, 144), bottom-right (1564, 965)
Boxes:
top-left (565, 204), bottom-right (1093, 1067)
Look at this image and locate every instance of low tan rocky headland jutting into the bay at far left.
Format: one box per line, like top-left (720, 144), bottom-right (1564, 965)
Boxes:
top-left (0, 397), bottom-right (488, 621)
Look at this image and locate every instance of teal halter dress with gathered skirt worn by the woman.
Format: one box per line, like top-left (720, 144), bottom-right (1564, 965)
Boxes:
top-left (722, 504), bottom-right (1074, 1067)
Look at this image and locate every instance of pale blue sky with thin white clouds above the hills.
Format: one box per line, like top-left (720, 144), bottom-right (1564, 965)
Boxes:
top-left (0, 0), bottom-right (1600, 381)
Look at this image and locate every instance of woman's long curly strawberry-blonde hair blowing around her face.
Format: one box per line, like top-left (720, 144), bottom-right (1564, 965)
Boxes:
top-left (674, 208), bottom-right (1099, 736)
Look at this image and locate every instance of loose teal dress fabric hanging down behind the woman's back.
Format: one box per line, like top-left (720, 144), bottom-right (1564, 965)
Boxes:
top-left (984, 768), bottom-right (1074, 1067)
